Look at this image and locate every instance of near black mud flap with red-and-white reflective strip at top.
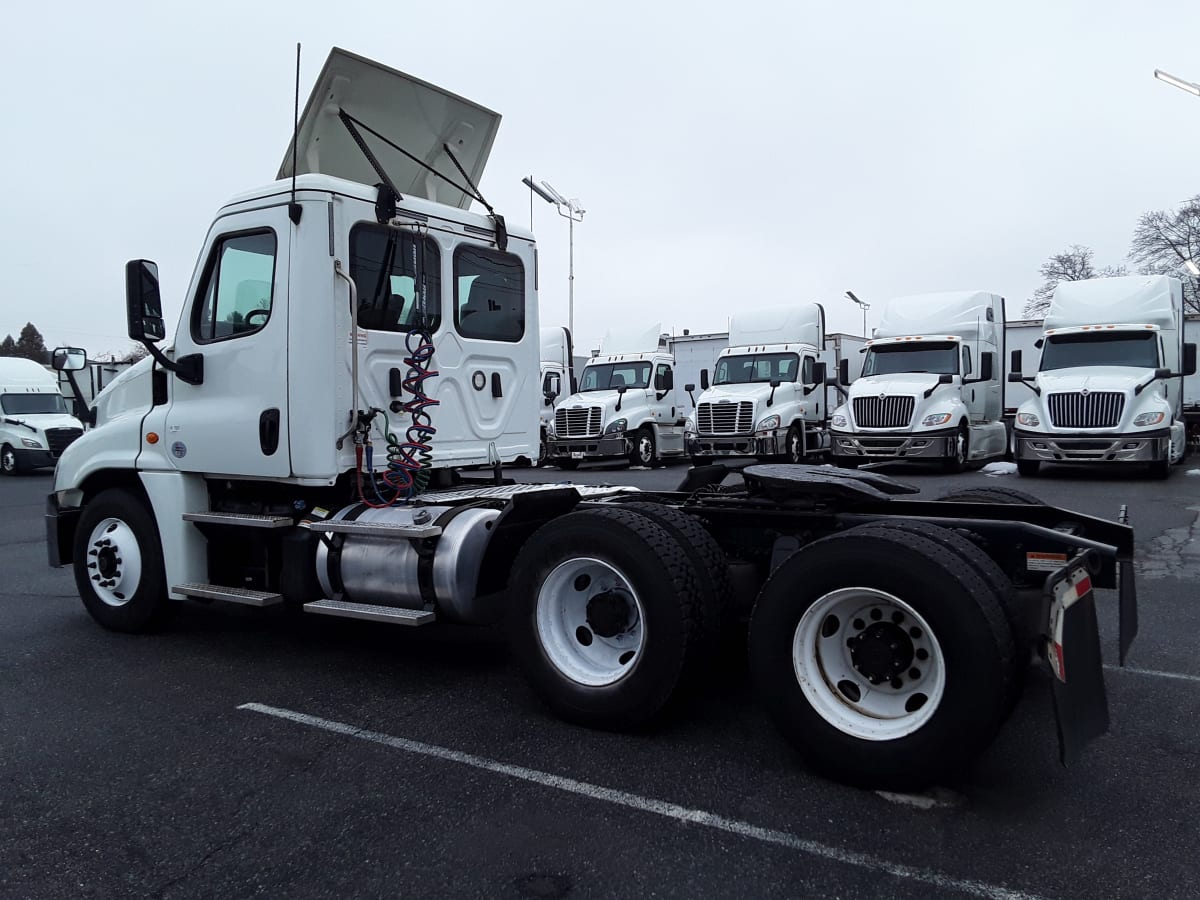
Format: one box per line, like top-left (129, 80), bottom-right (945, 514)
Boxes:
top-left (1044, 553), bottom-right (1108, 766)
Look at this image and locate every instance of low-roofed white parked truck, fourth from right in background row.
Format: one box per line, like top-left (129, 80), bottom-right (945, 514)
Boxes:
top-left (547, 325), bottom-right (688, 469)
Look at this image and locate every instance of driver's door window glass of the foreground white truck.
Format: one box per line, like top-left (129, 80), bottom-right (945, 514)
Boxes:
top-left (192, 232), bottom-right (275, 343)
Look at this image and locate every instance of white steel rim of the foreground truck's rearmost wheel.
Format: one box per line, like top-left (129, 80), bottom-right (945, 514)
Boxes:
top-left (792, 587), bottom-right (946, 740)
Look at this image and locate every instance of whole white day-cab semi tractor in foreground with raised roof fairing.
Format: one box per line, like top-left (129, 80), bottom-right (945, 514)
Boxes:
top-left (46, 49), bottom-right (1136, 788)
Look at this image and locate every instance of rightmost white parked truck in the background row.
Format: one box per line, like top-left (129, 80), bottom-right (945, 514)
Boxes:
top-left (1008, 275), bottom-right (1196, 478)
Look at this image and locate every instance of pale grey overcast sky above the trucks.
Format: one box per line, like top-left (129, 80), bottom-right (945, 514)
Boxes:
top-left (0, 0), bottom-right (1200, 354)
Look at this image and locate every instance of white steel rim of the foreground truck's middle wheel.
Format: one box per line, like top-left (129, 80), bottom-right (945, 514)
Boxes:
top-left (535, 557), bottom-right (646, 688)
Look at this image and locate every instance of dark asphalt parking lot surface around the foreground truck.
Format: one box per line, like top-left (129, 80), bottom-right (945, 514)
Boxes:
top-left (0, 466), bottom-right (1200, 898)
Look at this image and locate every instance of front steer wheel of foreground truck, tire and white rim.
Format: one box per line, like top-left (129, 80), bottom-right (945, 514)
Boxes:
top-left (73, 487), bottom-right (175, 634)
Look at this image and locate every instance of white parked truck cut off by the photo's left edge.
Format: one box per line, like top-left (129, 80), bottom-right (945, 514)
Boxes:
top-left (0, 356), bottom-right (83, 475)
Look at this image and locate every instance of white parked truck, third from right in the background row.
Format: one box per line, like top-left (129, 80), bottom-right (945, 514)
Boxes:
top-left (688, 304), bottom-right (829, 462)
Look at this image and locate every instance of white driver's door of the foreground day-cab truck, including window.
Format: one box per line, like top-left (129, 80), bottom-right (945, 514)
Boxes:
top-left (166, 205), bottom-right (292, 476)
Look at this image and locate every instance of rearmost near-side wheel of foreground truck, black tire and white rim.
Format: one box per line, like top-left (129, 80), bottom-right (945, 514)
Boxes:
top-left (750, 526), bottom-right (1014, 790)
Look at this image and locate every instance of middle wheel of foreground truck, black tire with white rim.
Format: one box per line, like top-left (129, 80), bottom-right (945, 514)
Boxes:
top-left (508, 508), bottom-right (703, 730)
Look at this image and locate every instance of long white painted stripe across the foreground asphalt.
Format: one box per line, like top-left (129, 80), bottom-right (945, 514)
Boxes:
top-left (238, 703), bottom-right (1036, 900)
